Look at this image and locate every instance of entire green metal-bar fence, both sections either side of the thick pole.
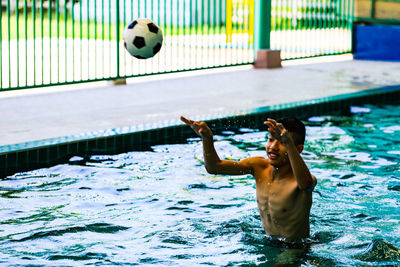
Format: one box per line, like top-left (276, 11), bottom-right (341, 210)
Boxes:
top-left (0, 0), bottom-right (353, 90)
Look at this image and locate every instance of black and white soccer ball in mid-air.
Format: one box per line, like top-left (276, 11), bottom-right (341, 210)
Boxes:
top-left (123, 19), bottom-right (163, 59)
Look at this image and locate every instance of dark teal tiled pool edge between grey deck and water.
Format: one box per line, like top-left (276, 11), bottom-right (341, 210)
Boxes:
top-left (0, 85), bottom-right (400, 179)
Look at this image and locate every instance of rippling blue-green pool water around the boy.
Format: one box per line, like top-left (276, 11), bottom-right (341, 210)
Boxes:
top-left (0, 106), bottom-right (400, 266)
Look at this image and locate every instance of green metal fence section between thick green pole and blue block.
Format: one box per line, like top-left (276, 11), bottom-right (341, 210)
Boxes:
top-left (271, 0), bottom-right (354, 59)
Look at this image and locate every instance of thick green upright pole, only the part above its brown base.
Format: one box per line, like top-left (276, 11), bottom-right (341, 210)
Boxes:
top-left (254, 0), bottom-right (271, 50)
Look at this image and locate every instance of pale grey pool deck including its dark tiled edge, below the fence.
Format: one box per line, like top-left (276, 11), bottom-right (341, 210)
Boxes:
top-left (0, 55), bottom-right (400, 178)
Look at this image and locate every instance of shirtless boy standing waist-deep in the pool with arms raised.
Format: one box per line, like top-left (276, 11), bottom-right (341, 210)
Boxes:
top-left (181, 117), bottom-right (317, 241)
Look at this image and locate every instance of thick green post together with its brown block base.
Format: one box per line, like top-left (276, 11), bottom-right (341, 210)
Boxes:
top-left (254, 0), bottom-right (281, 68)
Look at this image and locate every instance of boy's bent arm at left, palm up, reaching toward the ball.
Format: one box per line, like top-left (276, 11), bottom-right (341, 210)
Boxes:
top-left (180, 116), bottom-right (253, 175)
